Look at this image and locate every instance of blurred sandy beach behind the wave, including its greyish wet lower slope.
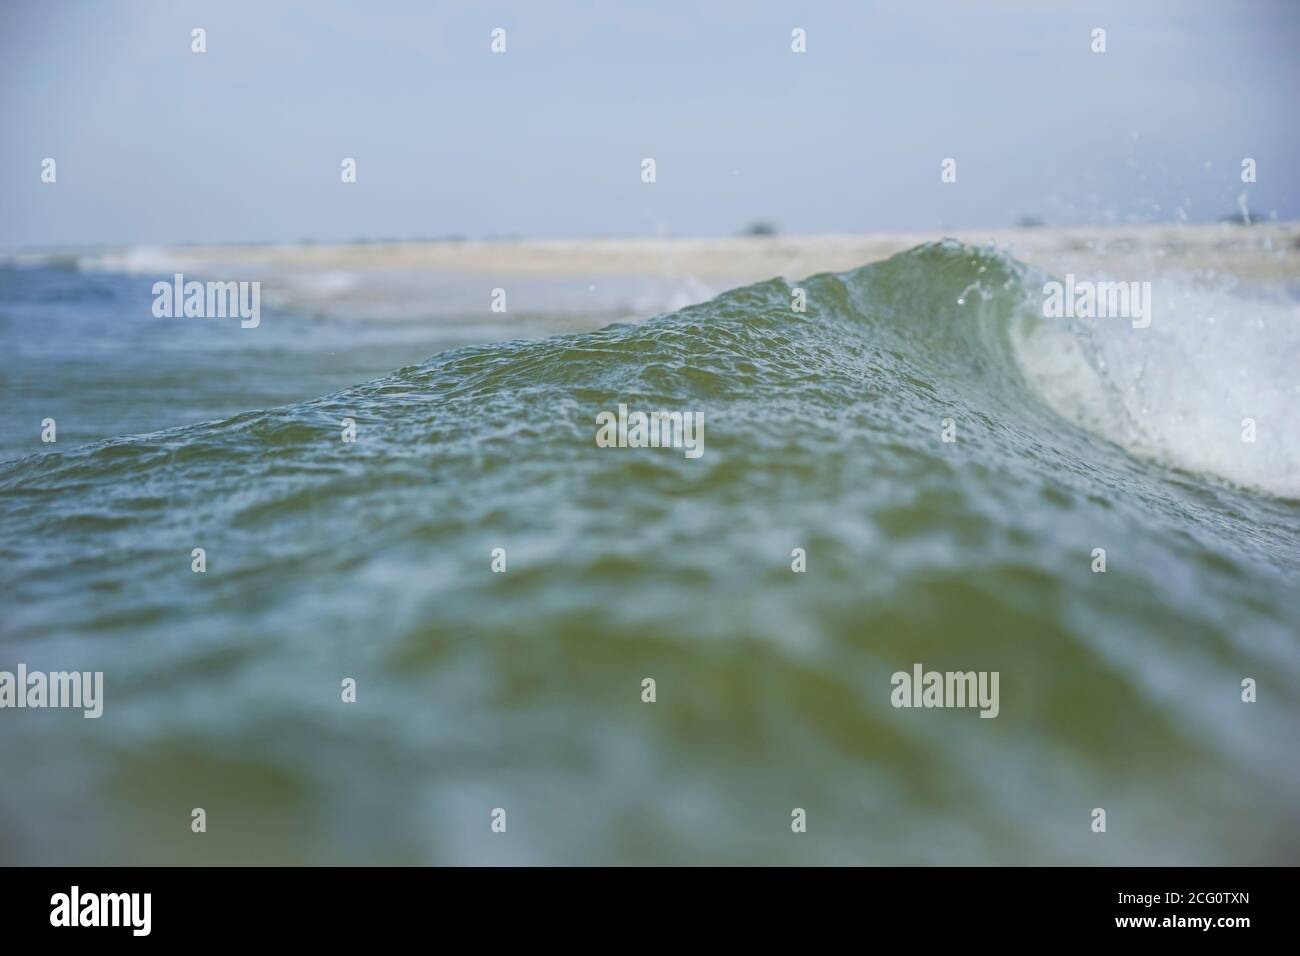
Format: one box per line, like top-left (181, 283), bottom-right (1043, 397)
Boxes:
top-left (12, 222), bottom-right (1300, 330)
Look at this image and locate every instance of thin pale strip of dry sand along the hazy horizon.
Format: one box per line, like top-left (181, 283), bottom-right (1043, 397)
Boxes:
top-left (4, 222), bottom-right (1300, 282)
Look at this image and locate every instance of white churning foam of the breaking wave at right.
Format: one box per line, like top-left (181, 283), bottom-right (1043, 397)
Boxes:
top-left (1013, 277), bottom-right (1300, 498)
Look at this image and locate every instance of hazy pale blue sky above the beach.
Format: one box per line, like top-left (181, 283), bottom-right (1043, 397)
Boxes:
top-left (0, 0), bottom-right (1300, 247)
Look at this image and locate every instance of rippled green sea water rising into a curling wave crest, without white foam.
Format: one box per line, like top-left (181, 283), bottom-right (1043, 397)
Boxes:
top-left (0, 243), bottom-right (1300, 864)
